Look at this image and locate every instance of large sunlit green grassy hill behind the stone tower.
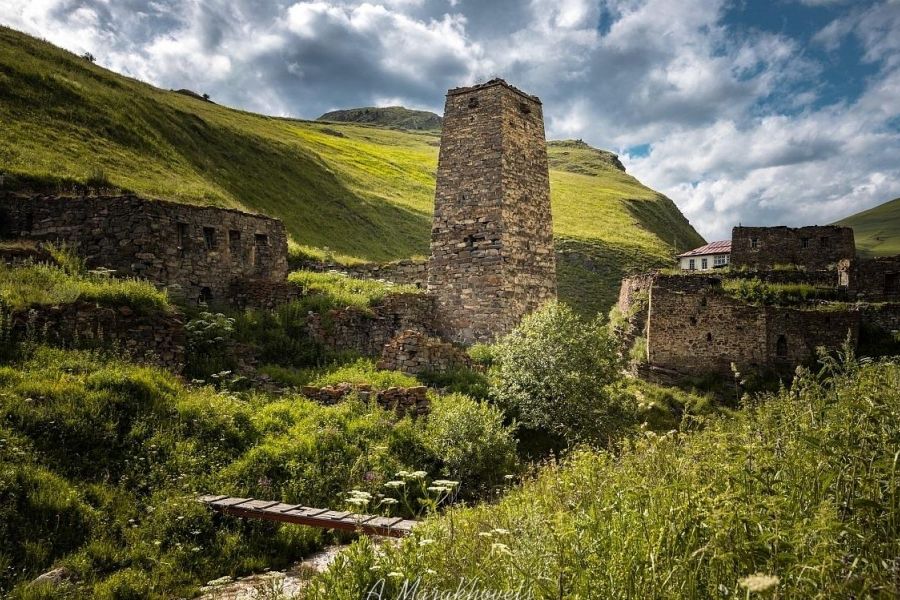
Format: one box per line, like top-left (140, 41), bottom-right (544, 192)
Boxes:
top-left (0, 27), bottom-right (702, 312)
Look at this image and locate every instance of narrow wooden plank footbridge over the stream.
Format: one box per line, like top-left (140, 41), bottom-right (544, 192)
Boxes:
top-left (198, 496), bottom-right (416, 537)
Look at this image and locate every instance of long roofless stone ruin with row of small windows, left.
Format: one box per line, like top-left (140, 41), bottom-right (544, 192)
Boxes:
top-left (0, 194), bottom-right (288, 301)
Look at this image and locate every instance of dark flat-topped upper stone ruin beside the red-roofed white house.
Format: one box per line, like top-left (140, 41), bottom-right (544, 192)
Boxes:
top-left (731, 225), bottom-right (856, 271)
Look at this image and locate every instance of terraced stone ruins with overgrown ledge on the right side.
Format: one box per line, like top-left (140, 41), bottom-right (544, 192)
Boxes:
top-left (617, 226), bottom-right (900, 380)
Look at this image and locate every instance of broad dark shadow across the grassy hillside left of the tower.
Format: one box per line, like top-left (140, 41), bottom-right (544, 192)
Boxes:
top-left (147, 104), bottom-right (431, 260)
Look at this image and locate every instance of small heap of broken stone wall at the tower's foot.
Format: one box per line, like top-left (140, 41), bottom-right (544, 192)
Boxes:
top-left (378, 331), bottom-right (472, 375)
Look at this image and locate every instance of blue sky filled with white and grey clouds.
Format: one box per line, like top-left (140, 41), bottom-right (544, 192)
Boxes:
top-left (0, 0), bottom-right (900, 239)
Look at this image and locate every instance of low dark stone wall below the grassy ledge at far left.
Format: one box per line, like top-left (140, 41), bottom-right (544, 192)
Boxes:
top-left (6, 302), bottom-right (186, 373)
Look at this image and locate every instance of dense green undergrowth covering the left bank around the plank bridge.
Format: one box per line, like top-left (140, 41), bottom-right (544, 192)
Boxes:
top-left (0, 347), bottom-right (516, 599)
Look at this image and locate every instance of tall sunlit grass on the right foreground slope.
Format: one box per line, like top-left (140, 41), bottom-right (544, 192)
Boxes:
top-left (309, 354), bottom-right (900, 599)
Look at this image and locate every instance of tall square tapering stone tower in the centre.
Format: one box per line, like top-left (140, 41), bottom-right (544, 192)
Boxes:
top-left (428, 79), bottom-right (556, 344)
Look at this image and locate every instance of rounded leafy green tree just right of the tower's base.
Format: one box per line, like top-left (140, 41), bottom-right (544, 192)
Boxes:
top-left (492, 302), bottom-right (634, 444)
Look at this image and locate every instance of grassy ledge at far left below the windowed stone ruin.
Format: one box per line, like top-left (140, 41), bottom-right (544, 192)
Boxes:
top-left (0, 263), bottom-right (170, 311)
